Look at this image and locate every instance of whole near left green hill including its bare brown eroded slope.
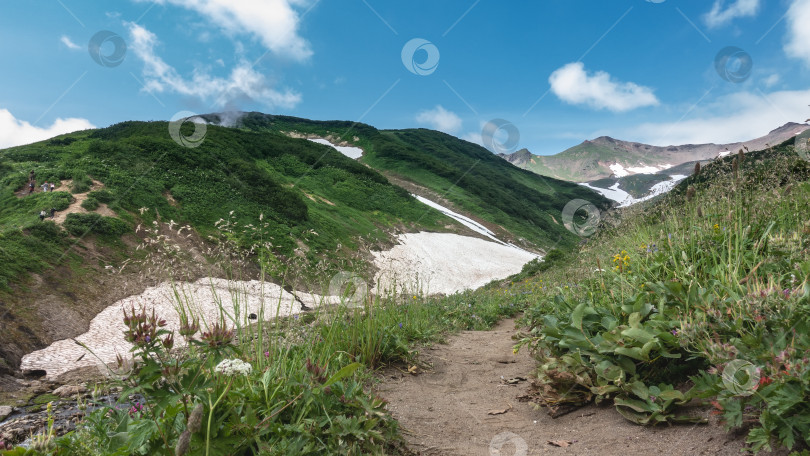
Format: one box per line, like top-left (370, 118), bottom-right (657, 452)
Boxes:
top-left (0, 122), bottom-right (454, 374)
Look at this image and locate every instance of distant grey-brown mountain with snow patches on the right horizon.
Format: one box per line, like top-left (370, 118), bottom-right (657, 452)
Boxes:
top-left (500, 123), bottom-right (810, 182)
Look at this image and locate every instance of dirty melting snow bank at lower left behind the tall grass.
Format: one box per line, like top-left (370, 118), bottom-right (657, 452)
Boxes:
top-left (20, 279), bottom-right (338, 380)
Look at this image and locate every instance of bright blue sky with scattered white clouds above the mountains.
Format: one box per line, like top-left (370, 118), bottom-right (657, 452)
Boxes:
top-left (0, 0), bottom-right (810, 154)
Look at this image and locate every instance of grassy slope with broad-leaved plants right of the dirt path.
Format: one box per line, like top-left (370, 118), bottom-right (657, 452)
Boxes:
top-left (521, 141), bottom-right (810, 454)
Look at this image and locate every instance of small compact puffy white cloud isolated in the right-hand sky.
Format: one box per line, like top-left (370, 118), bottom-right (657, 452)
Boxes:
top-left (548, 62), bottom-right (659, 112)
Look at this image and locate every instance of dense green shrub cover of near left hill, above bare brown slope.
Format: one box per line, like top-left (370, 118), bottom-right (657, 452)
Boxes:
top-left (0, 122), bottom-right (448, 278)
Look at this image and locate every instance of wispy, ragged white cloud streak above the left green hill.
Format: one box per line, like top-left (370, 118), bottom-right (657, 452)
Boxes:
top-left (128, 23), bottom-right (301, 108)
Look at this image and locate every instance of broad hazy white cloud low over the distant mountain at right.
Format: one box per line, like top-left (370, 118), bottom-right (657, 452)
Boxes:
top-left (628, 90), bottom-right (810, 146)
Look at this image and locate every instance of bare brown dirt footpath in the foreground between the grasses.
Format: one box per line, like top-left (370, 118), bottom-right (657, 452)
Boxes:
top-left (378, 320), bottom-right (786, 456)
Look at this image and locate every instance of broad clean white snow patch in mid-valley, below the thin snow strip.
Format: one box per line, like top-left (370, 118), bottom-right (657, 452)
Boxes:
top-left (372, 232), bottom-right (537, 294)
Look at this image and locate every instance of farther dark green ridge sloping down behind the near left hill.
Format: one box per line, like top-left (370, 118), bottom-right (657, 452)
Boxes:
top-left (211, 113), bottom-right (610, 249)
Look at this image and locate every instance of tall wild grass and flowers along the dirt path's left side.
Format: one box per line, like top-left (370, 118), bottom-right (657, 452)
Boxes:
top-left (7, 216), bottom-right (530, 455)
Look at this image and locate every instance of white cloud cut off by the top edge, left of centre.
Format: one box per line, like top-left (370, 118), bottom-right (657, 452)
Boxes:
top-left (140, 0), bottom-right (312, 60)
